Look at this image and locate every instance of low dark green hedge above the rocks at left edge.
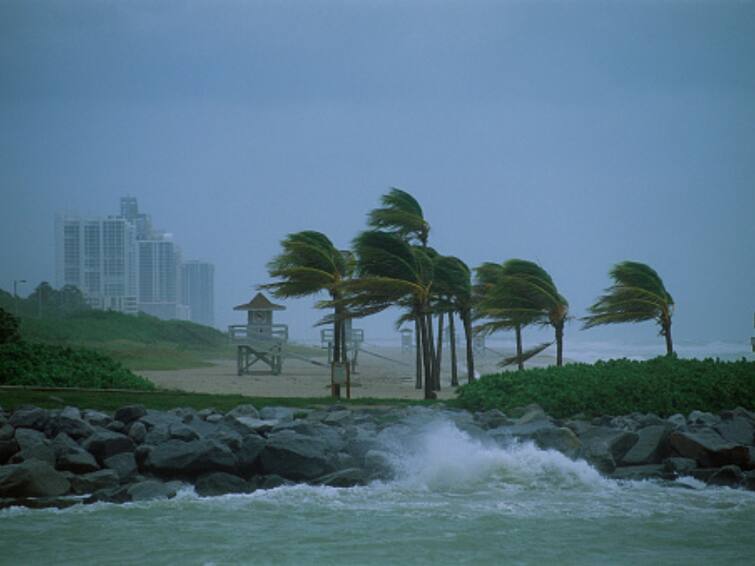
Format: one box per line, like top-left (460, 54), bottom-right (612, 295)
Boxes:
top-left (0, 342), bottom-right (155, 390)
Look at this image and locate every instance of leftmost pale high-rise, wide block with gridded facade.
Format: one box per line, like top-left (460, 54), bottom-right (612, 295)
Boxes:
top-left (55, 215), bottom-right (137, 313)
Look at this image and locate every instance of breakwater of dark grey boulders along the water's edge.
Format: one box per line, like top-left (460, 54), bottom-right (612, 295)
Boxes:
top-left (0, 405), bottom-right (755, 508)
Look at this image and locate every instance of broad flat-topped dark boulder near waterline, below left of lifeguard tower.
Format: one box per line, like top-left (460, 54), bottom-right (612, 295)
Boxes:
top-left (144, 439), bottom-right (237, 477)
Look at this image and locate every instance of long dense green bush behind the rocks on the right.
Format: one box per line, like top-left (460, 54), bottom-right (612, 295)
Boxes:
top-left (458, 357), bottom-right (755, 418)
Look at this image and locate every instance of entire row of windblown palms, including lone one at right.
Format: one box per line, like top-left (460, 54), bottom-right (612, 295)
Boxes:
top-left (261, 188), bottom-right (673, 399)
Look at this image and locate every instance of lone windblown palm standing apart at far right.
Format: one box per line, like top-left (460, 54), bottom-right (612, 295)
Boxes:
top-left (582, 261), bottom-right (674, 356)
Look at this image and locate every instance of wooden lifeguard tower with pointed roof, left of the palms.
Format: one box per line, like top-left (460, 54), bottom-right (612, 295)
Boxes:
top-left (228, 293), bottom-right (288, 375)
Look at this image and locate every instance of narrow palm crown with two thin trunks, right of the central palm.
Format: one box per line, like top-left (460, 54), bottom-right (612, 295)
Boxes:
top-left (433, 256), bottom-right (474, 386)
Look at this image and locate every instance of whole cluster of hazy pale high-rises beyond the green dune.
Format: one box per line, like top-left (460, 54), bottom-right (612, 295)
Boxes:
top-left (55, 197), bottom-right (214, 324)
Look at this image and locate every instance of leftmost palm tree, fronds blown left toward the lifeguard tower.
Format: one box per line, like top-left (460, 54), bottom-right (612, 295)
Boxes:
top-left (260, 230), bottom-right (352, 368)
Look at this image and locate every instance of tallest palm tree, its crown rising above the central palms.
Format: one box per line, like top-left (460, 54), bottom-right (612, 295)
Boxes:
top-left (367, 187), bottom-right (430, 389)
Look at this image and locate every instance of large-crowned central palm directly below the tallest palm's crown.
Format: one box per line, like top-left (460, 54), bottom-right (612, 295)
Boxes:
top-left (340, 231), bottom-right (435, 399)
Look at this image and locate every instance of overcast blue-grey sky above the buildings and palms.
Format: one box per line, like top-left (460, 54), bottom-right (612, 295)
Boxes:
top-left (0, 0), bottom-right (755, 351)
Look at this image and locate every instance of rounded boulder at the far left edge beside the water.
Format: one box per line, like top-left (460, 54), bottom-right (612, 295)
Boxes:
top-left (0, 460), bottom-right (71, 498)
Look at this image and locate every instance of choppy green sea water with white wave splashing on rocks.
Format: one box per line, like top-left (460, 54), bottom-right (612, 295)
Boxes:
top-left (0, 411), bottom-right (755, 565)
